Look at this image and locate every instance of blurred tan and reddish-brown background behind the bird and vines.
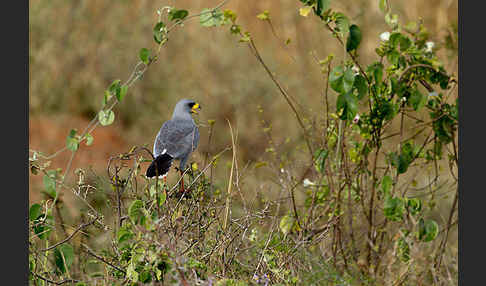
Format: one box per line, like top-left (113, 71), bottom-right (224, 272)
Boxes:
top-left (29, 0), bottom-right (457, 222)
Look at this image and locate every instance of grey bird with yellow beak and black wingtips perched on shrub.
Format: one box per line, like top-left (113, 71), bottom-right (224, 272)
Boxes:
top-left (146, 99), bottom-right (201, 192)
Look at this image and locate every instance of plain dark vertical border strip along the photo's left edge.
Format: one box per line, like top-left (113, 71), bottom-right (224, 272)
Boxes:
top-left (4, 1), bottom-right (29, 285)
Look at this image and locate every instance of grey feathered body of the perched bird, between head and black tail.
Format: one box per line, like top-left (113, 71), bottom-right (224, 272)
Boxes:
top-left (154, 120), bottom-right (199, 159)
